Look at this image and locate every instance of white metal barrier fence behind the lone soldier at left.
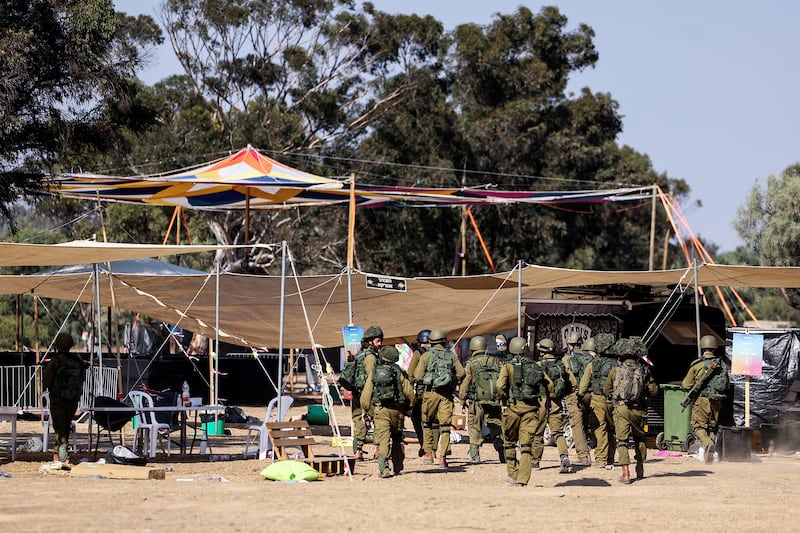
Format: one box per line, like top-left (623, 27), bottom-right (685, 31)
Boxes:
top-left (0, 365), bottom-right (119, 408)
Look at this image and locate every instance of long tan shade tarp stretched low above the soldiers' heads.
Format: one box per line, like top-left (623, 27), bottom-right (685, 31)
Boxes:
top-left (0, 258), bottom-right (800, 348)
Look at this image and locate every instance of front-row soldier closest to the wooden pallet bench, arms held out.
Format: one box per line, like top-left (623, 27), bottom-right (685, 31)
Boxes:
top-left (361, 346), bottom-right (415, 478)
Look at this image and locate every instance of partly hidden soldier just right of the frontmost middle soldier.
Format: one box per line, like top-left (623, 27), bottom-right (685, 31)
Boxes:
top-left (532, 339), bottom-right (572, 474)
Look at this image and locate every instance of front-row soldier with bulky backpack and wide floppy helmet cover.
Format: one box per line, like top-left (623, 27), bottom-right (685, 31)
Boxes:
top-left (603, 339), bottom-right (658, 485)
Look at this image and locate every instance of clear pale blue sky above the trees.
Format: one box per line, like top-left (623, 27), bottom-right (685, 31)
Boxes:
top-left (115, 0), bottom-right (800, 251)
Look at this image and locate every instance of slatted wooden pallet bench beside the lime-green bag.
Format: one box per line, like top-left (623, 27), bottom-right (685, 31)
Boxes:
top-left (267, 420), bottom-right (356, 477)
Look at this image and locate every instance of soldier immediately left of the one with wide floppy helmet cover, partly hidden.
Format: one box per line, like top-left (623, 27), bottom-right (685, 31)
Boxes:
top-left (578, 333), bottom-right (617, 470)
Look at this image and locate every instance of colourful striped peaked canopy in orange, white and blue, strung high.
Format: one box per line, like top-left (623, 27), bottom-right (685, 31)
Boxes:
top-left (50, 147), bottom-right (653, 211)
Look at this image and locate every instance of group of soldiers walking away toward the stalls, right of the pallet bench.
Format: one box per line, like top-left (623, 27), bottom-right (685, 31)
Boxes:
top-left (339, 326), bottom-right (729, 486)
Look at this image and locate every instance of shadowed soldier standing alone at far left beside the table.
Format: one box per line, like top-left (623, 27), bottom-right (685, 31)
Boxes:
top-left (42, 331), bottom-right (87, 464)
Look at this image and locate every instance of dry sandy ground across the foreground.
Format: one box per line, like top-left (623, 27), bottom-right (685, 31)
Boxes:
top-left (0, 400), bottom-right (800, 532)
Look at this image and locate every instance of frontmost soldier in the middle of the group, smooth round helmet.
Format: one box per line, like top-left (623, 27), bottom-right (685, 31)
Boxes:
top-left (497, 337), bottom-right (553, 486)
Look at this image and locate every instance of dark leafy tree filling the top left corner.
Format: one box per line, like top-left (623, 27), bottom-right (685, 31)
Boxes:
top-left (0, 0), bottom-right (161, 231)
